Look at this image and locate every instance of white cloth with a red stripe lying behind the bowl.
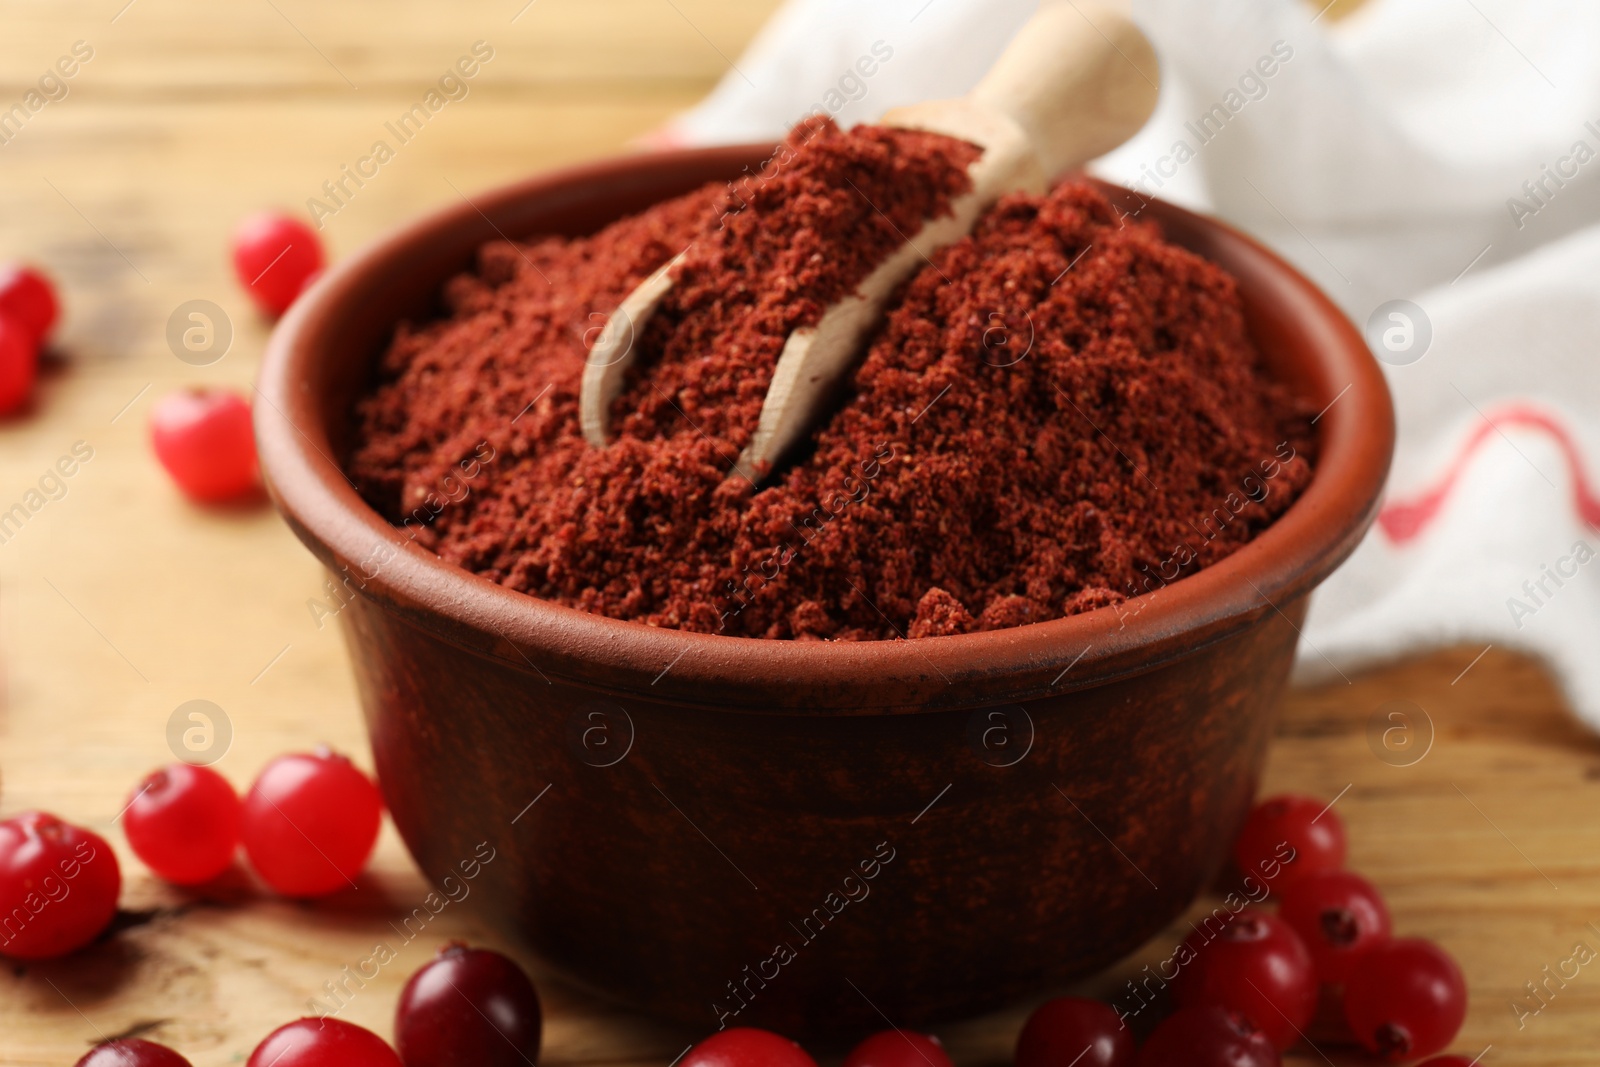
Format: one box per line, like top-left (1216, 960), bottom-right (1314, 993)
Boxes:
top-left (654, 0), bottom-right (1600, 728)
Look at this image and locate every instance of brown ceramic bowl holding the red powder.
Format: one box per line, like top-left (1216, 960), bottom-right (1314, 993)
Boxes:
top-left (256, 147), bottom-right (1394, 1037)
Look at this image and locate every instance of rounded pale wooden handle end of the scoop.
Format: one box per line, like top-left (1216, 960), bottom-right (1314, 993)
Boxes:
top-left (968, 0), bottom-right (1160, 178)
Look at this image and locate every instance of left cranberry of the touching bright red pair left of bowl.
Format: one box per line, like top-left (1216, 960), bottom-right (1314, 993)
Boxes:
top-left (122, 763), bottom-right (238, 886)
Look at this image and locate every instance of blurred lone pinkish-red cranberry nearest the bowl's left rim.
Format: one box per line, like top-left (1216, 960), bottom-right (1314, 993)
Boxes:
top-left (150, 389), bottom-right (256, 502)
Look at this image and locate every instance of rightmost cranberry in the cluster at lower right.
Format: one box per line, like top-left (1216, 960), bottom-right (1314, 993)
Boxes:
top-left (1344, 937), bottom-right (1467, 1059)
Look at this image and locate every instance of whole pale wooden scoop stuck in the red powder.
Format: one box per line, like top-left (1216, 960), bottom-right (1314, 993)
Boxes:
top-left (578, 0), bottom-right (1158, 480)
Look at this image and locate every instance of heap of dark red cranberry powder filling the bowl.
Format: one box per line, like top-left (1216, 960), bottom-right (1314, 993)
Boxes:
top-left (349, 122), bottom-right (1312, 640)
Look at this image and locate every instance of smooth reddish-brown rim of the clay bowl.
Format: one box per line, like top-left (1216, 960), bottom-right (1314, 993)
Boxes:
top-left (254, 146), bottom-right (1395, 713)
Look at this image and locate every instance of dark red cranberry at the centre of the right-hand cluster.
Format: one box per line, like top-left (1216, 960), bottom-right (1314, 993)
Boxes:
top-left (1173, 910), bottom-right (1317, 1049)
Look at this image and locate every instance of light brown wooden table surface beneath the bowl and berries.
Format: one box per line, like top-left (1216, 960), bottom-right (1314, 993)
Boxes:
top-left (0, 0), bottom-right (1600, 1067)
